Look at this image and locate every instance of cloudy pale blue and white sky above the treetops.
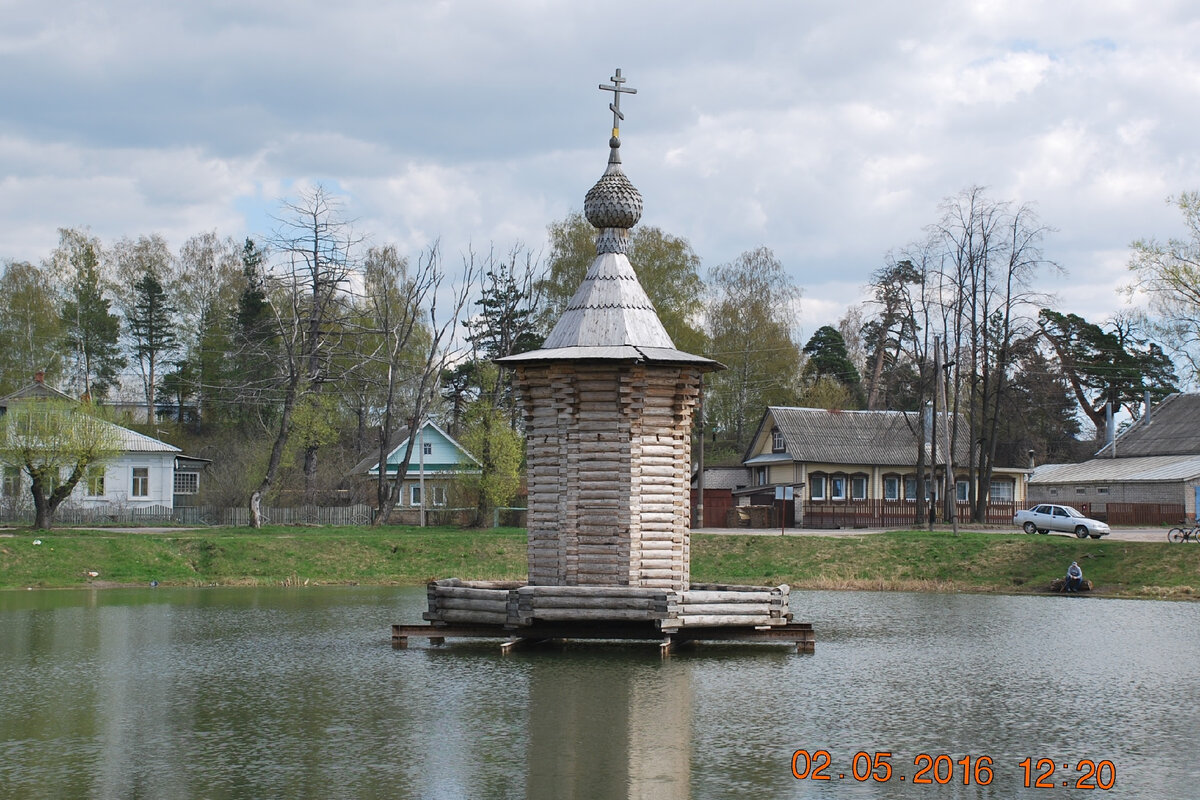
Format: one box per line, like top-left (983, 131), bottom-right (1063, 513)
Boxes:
top-left (0, 0), bottom-right (1200, 341)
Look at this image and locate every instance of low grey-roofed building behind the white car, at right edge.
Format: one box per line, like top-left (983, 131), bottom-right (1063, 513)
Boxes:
top-left (1028, 392), bottom-right (1200, 524)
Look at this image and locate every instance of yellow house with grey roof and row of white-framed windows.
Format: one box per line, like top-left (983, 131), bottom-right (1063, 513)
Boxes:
top-left (733, 405), bottom-right (1027, 528)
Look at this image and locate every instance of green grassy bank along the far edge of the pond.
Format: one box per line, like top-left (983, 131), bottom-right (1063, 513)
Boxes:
top-left (0, 527), bottom-right (1200, 600)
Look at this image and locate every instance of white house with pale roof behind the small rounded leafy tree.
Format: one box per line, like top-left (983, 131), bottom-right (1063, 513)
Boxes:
top-left (0, 373), bottom-right (209, 518)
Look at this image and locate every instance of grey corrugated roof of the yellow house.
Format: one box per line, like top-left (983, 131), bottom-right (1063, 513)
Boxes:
top-left (760, 405), bottom-right (967, 467)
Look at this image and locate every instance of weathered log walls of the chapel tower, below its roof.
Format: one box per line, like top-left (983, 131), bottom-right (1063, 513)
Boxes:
top-left (516, 362), bottom-right (700, 589)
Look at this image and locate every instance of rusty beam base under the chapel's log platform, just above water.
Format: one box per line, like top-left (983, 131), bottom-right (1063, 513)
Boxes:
top-left (391, 621), bottom-right (816, 656)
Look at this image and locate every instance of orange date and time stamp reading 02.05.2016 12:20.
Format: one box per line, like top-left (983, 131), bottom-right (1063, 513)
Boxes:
top-left (792, 750), bottom-right (1117, 789)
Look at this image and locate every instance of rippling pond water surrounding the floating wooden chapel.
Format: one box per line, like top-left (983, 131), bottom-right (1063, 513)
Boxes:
top-left (0, 588), bottom-right (1200, 800)
